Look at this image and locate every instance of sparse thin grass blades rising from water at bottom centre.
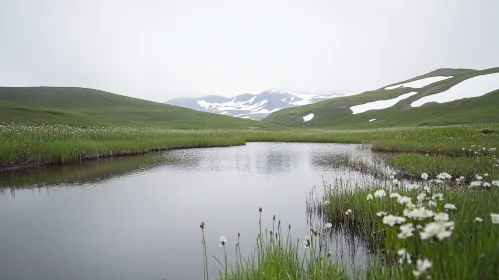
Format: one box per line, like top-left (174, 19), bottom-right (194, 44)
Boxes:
top-left (202, 211), bottom-right (348, 279)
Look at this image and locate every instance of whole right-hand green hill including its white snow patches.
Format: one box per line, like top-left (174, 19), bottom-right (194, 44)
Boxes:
top-left (263, 67), bottom-right (499, 129)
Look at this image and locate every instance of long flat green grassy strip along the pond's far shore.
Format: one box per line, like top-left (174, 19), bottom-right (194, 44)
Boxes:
top-left (0, 124), bottom-right (499, 171)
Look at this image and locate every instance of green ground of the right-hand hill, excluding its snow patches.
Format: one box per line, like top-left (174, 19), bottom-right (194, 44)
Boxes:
top-left (263, 67), bottom-right (499, 129)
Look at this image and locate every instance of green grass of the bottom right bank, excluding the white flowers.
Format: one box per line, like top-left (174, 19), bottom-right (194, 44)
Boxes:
top-left (314, 176), bottom-right (499, 279)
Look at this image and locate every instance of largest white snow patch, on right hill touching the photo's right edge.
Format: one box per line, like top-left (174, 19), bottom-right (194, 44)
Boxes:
top-left (411, 73), bottom-right (499, 107)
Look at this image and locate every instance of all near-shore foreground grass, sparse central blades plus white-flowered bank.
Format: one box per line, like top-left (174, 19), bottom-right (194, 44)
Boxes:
top-left (202, 167), bottom-right (499, 279)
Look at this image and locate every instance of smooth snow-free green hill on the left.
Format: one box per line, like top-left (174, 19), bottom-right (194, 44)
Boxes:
top-left (0, 87), bottom-right (265, 129)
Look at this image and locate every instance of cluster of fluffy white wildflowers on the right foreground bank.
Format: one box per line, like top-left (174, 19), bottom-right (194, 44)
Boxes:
top-left (360, 172), bottom-right (499, 277)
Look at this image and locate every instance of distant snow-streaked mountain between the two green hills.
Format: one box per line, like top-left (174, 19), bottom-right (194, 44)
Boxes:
top-left (166, 89), bottom-right (343, 120)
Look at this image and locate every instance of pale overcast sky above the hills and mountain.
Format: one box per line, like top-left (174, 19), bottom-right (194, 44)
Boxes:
top-left (0, 0), bottom-right (499, 102)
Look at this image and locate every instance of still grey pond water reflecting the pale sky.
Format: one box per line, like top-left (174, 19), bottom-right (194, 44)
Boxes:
top-left (0, 143), bottom-right (376, 280)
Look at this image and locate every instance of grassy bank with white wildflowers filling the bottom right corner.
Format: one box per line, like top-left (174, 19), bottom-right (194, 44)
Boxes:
top-left (316, 174), bottom-right (499, 279)
